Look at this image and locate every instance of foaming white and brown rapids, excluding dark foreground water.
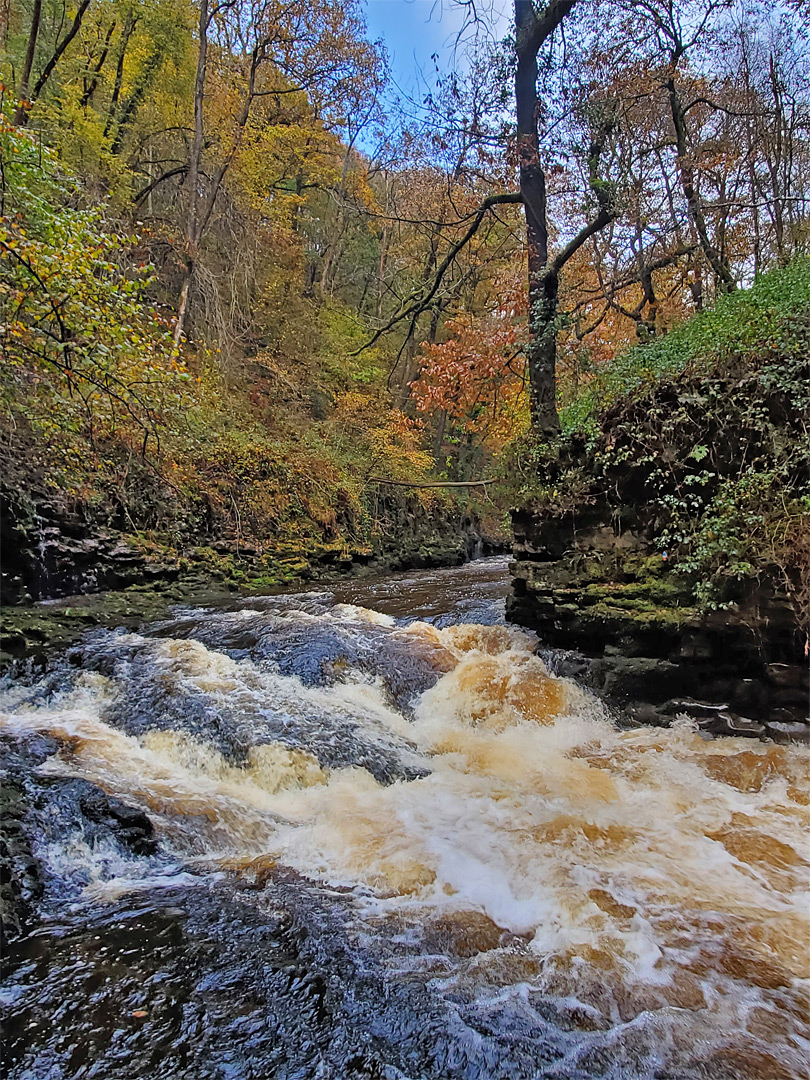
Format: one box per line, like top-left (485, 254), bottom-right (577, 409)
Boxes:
top-left (0, 565), bottom-right (810, 1080)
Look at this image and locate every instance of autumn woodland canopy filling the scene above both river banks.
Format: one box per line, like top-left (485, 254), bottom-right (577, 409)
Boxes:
top-left (0, 0), bottom-right (810, 548)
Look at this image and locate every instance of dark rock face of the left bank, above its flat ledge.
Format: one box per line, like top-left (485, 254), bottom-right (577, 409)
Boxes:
top-left (0, 490), bottom-right (505, 605)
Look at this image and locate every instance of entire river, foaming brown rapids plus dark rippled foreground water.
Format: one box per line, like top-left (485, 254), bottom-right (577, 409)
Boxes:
top-left (0, 559), bottom-right (810, 1080)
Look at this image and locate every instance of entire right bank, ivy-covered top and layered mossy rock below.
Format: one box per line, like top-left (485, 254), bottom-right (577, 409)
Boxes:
top-left (509, 260), bottom-right (810, 738)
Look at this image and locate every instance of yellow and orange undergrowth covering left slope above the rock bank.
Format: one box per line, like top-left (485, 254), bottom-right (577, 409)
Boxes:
top-left (0, 117), bottom-right (462, 549)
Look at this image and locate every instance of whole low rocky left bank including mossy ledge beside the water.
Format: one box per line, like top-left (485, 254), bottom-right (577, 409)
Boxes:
top-left (0, 488), bottom-right (507, 671)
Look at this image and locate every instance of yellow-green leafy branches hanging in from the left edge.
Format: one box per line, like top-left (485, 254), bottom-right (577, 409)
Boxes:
top-left (0, 125), bottom-right (187, 477)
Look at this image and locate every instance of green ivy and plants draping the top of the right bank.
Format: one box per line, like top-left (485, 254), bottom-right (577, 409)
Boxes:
top-left (533, 258), bottom-right (810, 624)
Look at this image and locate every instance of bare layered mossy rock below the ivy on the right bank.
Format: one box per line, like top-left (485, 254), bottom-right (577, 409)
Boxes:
top-left (508, 500), bottom-right (808, 740)
